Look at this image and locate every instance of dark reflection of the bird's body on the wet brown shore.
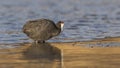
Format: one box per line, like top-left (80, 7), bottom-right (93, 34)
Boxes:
top-left (23, 43), bottom-right (60, 60)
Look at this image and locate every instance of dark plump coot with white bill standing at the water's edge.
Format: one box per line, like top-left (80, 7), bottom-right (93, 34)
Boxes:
top-left (23, 19), bottom-right (64, 42)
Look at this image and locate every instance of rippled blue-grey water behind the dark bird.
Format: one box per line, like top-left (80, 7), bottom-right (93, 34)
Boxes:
top-left (0, 0), bottom-right (120, 43)
